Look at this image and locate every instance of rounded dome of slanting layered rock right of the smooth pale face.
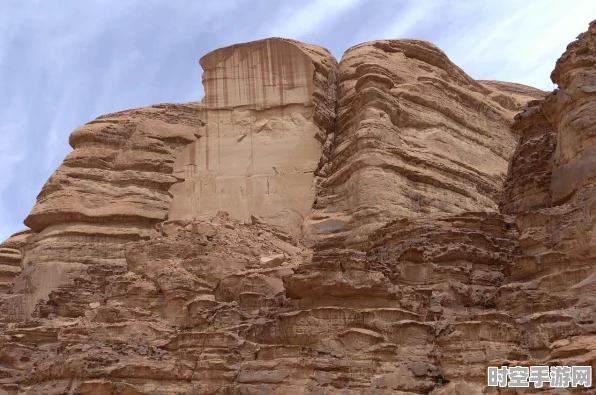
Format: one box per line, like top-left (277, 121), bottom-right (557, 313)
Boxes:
top-left (309, 40), bottom-right (544, 243)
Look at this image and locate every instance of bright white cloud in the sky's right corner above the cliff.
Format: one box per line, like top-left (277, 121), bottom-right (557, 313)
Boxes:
top-left (429, 0), bottom-right (596, 90)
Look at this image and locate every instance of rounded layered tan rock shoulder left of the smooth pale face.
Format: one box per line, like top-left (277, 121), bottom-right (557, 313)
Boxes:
top-left (14, 103), bottom-right (202, 317)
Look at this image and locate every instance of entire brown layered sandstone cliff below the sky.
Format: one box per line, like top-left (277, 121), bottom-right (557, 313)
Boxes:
top-left (0, 21), bottom-right (596, 395)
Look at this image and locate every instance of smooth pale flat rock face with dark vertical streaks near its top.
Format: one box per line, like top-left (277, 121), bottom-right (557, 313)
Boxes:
top-left (170, 39), bottom-right (337, 240)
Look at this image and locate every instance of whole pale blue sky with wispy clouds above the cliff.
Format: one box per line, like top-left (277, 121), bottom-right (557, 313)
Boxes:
top-left (0, 0), bottom-right (596, 241)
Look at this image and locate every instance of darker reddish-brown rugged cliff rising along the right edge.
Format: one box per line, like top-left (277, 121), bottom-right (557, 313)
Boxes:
top-left (497, 18), bottom-right (596, 376)
